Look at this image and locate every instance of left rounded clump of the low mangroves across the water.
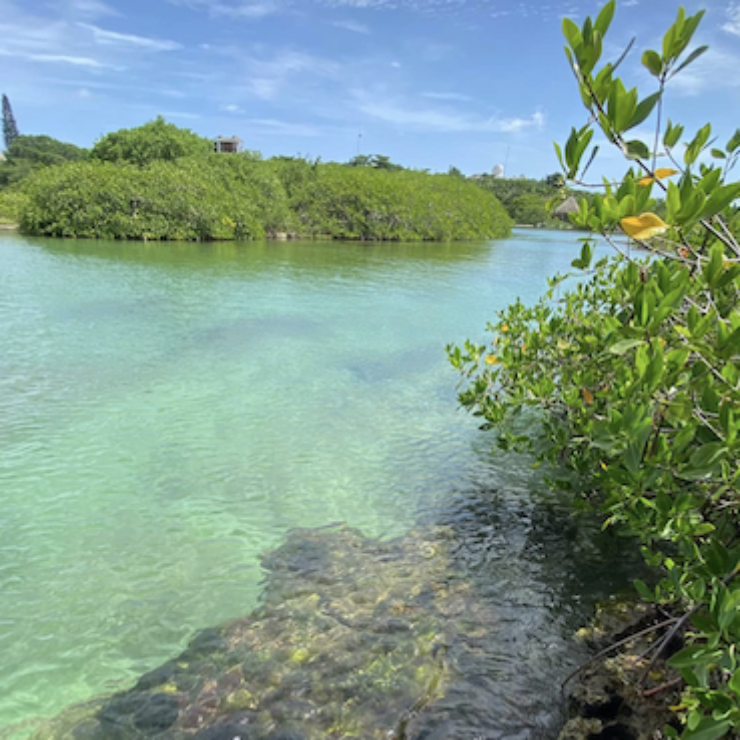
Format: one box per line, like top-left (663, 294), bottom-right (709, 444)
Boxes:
top-left (20, 154), bottom-right (291, 240)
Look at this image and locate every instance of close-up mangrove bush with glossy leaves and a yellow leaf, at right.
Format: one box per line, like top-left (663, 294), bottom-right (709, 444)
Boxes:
top-left (449, 2), bottom-right (740, 740)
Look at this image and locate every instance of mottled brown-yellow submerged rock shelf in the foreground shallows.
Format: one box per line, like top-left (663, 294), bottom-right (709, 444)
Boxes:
top-left (34, 526), bottom-right (494, 740)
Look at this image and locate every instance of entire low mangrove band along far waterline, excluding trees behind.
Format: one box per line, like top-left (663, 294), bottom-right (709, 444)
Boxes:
top-left (20, 154), bottom-right (510, 241)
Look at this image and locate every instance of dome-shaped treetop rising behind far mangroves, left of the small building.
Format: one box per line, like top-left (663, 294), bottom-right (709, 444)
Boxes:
top-left (92, 116), bottom-right (213, 166)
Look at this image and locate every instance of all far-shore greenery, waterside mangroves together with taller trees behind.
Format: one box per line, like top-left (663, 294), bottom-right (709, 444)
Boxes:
top-left (0, 118), bottom-right (513, 241)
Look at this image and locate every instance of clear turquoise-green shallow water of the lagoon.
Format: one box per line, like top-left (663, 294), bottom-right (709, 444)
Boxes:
top-left (0, 232), bottom-right (636, 728)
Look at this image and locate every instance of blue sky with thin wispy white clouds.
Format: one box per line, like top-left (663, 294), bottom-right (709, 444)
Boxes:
top-left (0, 0), bottom-right (740, 178)
